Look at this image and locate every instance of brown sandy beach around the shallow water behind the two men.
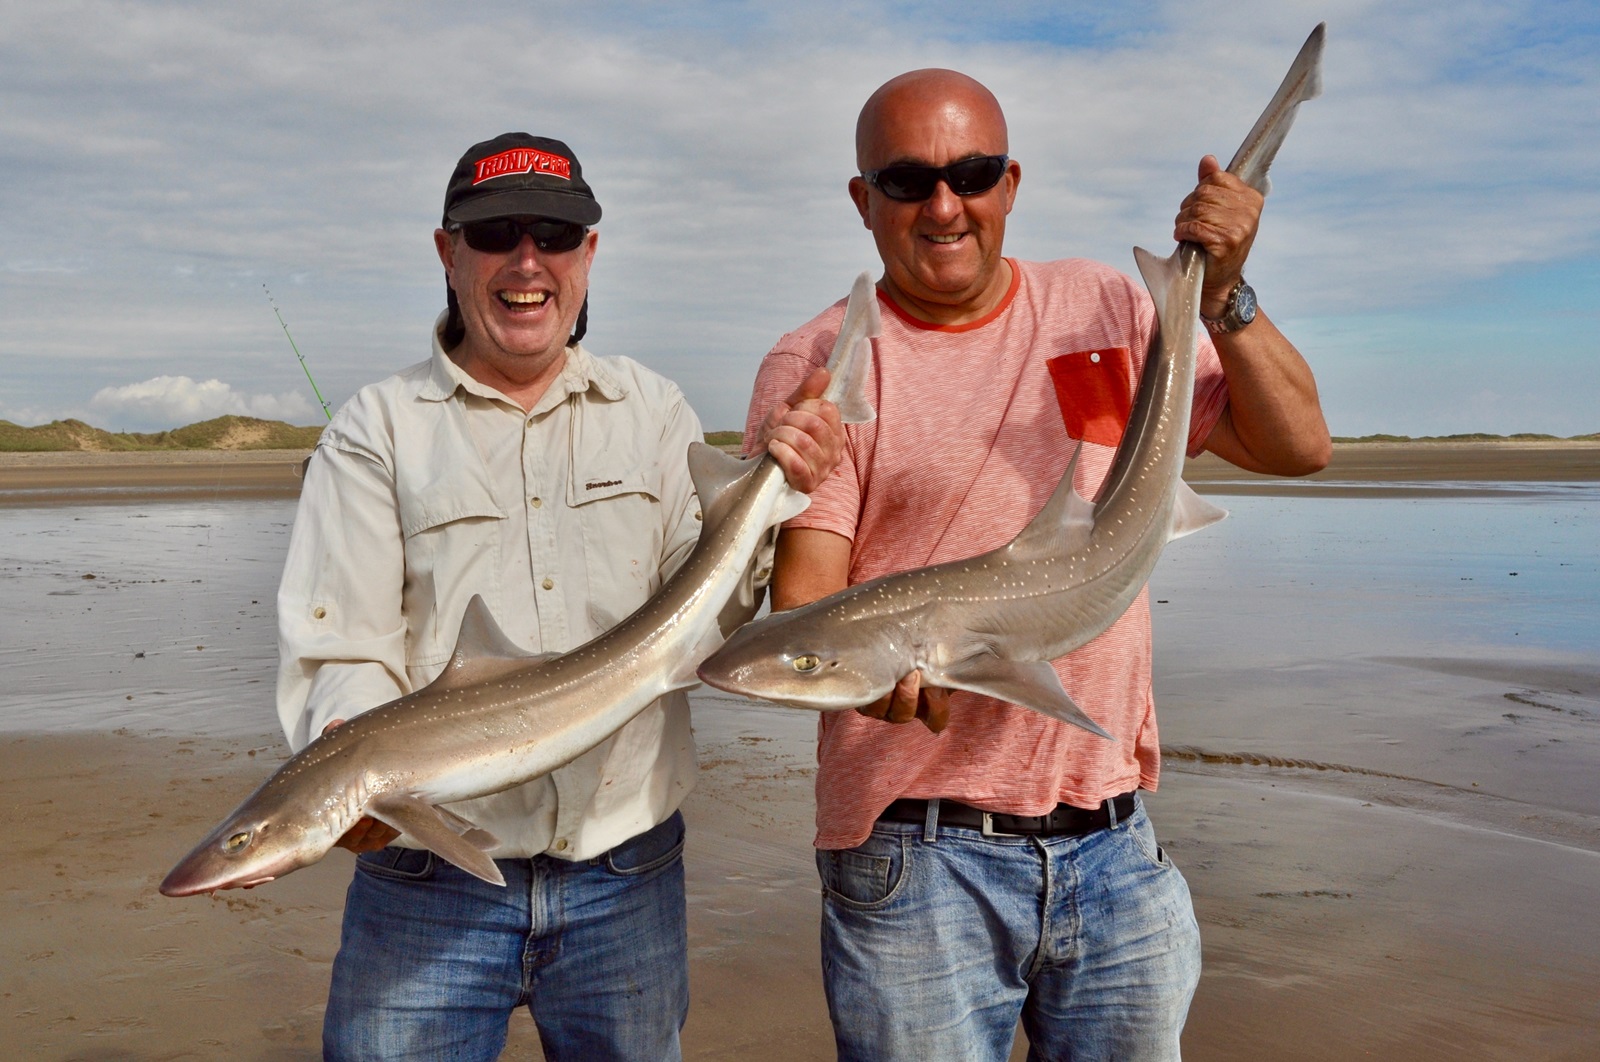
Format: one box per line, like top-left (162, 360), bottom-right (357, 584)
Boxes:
top-left (0, 443), bottom-right (1600, 1062)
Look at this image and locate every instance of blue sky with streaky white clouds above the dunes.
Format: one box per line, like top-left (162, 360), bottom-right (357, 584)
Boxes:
top-left (0, 0), bottom-right (1600, 437)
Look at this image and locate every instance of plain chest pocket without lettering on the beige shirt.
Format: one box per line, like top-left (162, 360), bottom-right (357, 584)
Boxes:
top-left (398, 478), bottom-right (506, 671)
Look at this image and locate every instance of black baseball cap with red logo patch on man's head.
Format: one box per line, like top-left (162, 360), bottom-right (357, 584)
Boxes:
top-left (445, 133), bottom-right (600, 227)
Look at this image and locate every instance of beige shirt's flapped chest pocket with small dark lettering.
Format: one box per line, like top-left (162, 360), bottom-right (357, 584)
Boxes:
top-left (566, 461), bottom-right (666, 630)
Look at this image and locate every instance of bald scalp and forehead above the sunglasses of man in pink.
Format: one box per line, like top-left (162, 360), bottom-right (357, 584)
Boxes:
top-left (856, 69), bottom-right (1010, 170)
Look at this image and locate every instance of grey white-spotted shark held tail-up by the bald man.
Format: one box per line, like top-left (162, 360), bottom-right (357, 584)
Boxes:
top-left (699, 26), bottom-right (1323, 739)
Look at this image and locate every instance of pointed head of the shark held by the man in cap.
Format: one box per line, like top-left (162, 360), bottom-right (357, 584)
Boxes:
top-left (160, 779), bottom-right (339, 896)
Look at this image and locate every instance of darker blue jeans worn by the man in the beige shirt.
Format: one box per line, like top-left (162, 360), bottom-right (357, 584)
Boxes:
top-left (322, 814), bottom-right (690, 1062)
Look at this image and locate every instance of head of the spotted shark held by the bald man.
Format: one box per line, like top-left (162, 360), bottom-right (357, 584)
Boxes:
top-left (699, 606), bottom-right (910, 712)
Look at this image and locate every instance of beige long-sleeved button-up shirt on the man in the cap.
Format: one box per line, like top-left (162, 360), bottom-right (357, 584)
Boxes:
top-left (278, 323), bottom-right (701, 859)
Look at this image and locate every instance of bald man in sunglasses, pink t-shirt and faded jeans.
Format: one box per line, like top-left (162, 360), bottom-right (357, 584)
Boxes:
top-left (750, 70), bottom-right (1330, 1062)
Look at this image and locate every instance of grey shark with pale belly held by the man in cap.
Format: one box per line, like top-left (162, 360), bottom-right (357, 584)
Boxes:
top-left (160, 273), bottom-right (880, 896)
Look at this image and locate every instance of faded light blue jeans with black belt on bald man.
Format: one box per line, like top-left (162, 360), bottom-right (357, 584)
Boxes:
top-left (816, 803), bottom-right (1200, 1062)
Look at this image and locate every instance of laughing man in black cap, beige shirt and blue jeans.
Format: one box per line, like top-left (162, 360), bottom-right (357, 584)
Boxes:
top-left (278, 133), bottom-right (842, 1062)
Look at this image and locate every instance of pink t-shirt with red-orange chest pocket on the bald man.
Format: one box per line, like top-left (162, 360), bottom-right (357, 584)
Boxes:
top-left (746, 259), bottom-right (1227, 848)
